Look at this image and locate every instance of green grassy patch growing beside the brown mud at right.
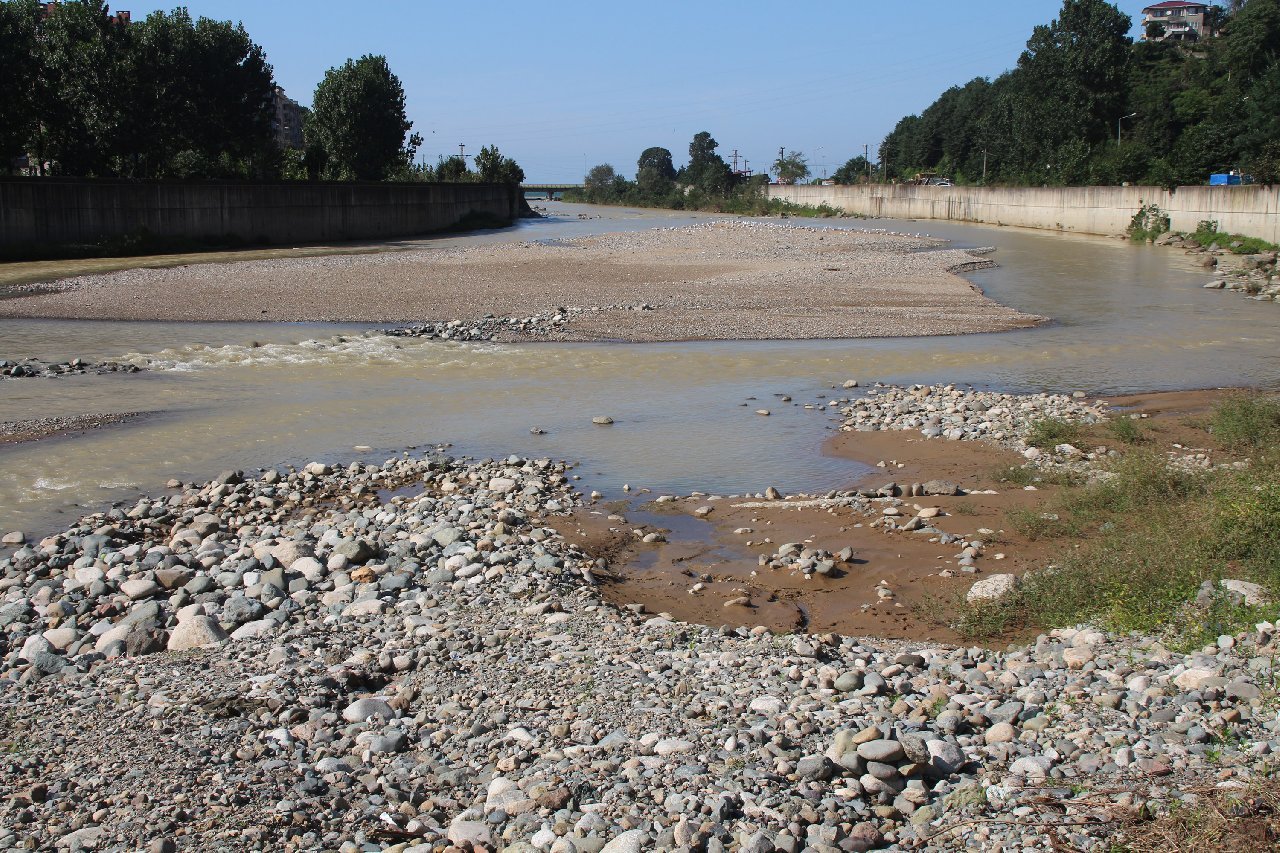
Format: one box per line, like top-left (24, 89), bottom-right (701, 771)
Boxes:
top-left (933, 397), bottom-right (1280, 648)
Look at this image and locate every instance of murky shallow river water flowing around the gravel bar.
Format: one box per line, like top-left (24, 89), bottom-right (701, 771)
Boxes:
top-left (0, 204), bottom-right (1280, 534)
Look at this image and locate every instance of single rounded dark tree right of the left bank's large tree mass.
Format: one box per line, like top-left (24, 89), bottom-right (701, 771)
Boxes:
top-left (308, 55), bottom-right (421, 181)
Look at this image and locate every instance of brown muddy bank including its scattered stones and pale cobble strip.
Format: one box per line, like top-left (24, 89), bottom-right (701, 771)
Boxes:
top-left (556, 387), bottom-right (1238, 642)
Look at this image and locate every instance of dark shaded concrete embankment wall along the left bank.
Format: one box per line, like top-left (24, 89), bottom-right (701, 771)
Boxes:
top-left (0, 178), bottom-right (521, 256)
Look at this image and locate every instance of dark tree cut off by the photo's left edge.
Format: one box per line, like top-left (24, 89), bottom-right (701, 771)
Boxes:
top-left (0, 0), bottom-right (40, 172)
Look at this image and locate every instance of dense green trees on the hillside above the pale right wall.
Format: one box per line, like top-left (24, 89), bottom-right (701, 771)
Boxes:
top-left (879, 0), bottom-right (1280, 186)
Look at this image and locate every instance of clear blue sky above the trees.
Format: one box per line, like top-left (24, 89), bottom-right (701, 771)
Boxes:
top-left (113, 0), bottom-right (1162, 182)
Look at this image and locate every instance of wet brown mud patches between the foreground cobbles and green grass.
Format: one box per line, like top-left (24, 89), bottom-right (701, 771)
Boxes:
top-left (557, 391), bottom-right (1230, 642)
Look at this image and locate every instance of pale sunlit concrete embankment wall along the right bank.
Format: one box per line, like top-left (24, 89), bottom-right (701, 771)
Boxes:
top-left (769, 184), bottom-right (1280, 243)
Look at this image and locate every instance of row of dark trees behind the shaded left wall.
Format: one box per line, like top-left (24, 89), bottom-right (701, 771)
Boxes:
top-left (0, 0), bottom-right (524, 183)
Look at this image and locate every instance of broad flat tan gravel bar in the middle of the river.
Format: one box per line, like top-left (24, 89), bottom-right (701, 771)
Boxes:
top-left (0, 220), bottom-right (1042, 341)
